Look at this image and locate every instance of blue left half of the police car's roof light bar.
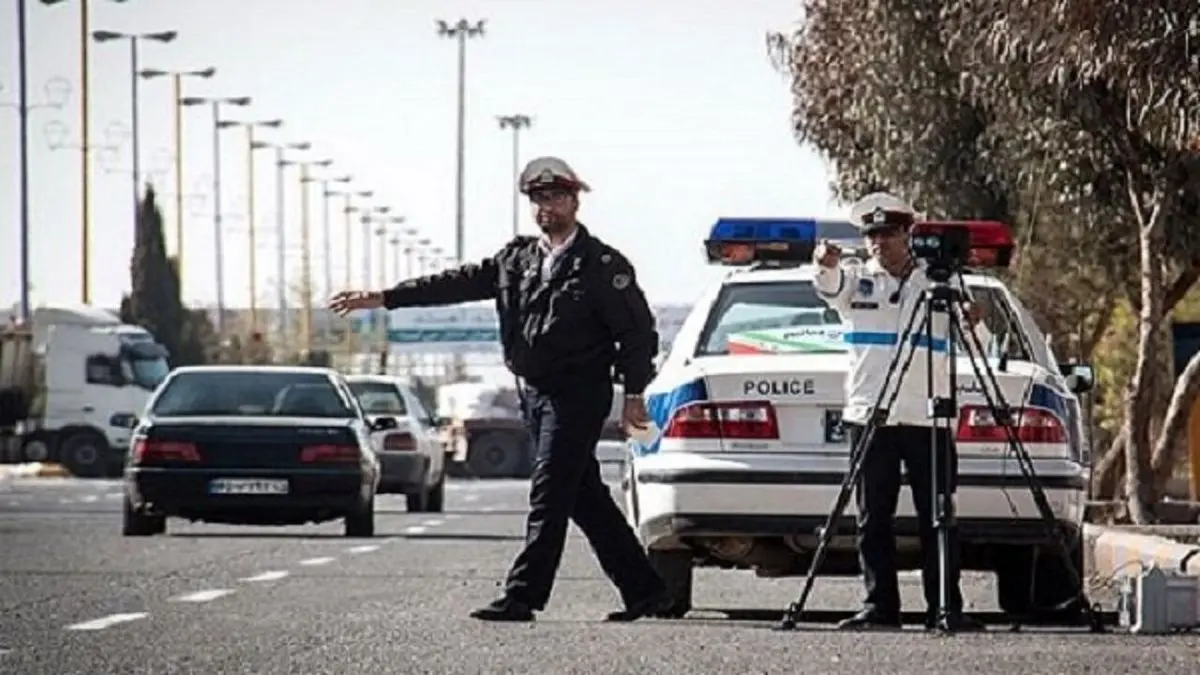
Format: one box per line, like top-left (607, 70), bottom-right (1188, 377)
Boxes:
top-left (704, 217), bottom-right (862, 267)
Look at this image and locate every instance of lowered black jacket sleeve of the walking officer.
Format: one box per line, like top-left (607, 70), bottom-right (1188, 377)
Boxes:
top-left (596, 251), bottom-right (659, 395)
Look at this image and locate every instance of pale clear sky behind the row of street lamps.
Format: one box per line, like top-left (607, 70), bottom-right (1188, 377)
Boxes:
top-left (0, 0), bottom-right (839, 306)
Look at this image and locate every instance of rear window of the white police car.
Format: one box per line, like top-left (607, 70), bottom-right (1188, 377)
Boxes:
top-left (696, 281), bottom-right (1031, 360)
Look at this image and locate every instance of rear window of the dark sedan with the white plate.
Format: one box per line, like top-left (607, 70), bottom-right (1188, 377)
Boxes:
top-left (150, 370), bottom-right (356, 418)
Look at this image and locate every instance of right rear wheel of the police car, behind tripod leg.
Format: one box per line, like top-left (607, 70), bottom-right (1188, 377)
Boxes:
top-left (996, 539), bottom-right (1084, 623)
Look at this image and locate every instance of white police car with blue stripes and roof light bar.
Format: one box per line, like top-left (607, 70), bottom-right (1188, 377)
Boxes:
top-left (622, 219), bottom-right (1093, 619)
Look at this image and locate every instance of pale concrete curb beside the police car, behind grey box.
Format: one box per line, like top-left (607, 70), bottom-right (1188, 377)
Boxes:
top-left (1084, 525), bottom-right (1200, 580)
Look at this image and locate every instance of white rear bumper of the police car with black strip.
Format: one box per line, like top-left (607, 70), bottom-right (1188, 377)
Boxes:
top-left (623, 455), bottom-right (1086, 545)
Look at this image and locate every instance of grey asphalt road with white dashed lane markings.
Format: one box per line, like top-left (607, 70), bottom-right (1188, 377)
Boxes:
top-left (0, 461), bottom-right (1200, 675)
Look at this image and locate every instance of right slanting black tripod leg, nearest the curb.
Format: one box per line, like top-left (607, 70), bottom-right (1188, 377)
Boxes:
top-left (950, 307), bottom-right (1104, 633)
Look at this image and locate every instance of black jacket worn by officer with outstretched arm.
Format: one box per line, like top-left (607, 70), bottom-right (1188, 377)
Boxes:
top-left (384, 226), bottom-right (659, 394)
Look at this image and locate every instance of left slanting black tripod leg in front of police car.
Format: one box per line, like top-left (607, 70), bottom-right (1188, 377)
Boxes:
top-left (778, 299), bottom-right (928, 631)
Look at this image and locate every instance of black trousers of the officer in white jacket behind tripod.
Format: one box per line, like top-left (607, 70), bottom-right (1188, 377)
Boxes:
top-left (847, 424), bottom-right (962, 619)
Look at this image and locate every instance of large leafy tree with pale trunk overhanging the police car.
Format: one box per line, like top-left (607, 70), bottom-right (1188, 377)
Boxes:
top-left (772, 0), bottom-right (1200, 521)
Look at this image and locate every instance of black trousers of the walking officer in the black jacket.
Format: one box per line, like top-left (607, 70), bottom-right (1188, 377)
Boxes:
top-left (505, 377), bottom-right (664, 610)
